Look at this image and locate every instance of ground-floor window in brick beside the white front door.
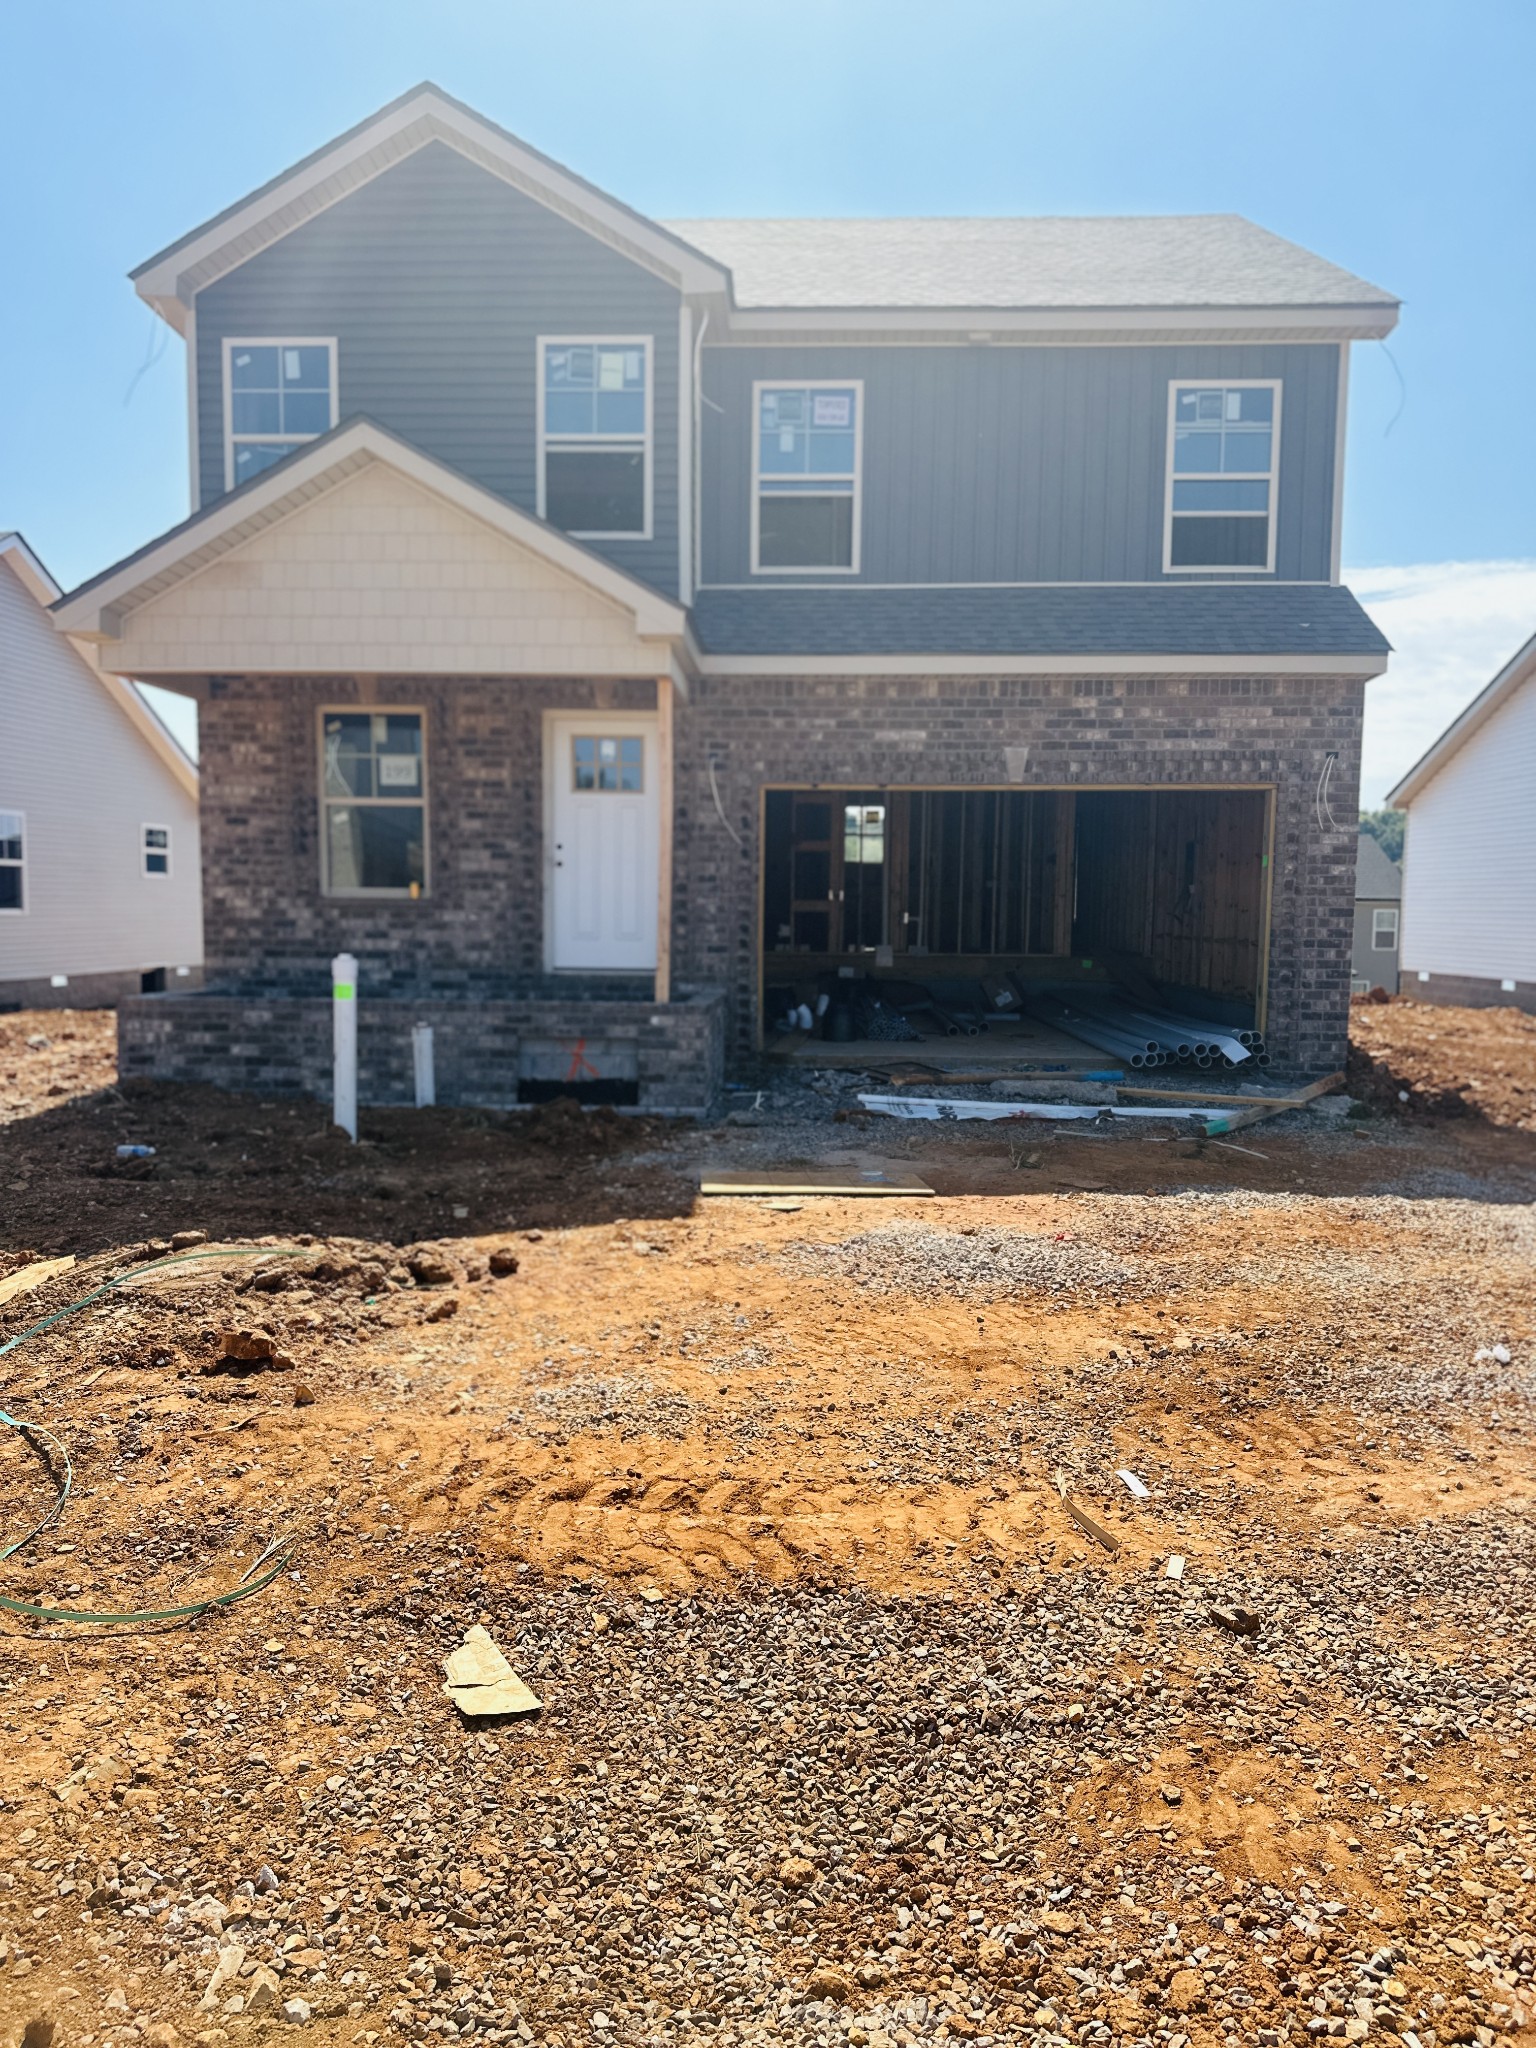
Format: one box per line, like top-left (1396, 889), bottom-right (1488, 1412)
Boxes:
top-left (319, 711), bottom-right (426, 897)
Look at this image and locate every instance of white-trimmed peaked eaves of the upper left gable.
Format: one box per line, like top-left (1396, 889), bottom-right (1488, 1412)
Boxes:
top-left (129, 80), bottom-right (729, 334)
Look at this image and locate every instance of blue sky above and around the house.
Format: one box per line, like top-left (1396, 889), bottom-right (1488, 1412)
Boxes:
top-left (0, 0), bottom-right (1536, 794)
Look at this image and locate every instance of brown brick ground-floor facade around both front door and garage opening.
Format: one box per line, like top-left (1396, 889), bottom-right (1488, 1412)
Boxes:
top-left (167, 676), bottom-right (1364, 1100)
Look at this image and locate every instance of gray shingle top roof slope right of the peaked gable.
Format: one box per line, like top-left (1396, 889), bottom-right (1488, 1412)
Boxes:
top-left (659, 213), bottom-right (1397, 309)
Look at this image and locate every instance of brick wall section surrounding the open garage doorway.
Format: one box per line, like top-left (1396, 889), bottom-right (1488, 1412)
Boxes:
top-left (674, 676), bottom-right (1364, 1071)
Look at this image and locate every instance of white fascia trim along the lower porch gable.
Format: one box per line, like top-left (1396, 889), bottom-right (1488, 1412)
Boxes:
top-left (53, 420), bottom-right (688, 641)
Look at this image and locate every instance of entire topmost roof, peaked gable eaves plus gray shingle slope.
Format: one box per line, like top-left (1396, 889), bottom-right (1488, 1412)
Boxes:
top-left (131, 82), bottom-right (1397, 338)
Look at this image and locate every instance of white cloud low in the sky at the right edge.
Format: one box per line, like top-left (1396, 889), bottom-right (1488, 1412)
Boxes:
top-left (1343, 561), bottom-right (1536, 809)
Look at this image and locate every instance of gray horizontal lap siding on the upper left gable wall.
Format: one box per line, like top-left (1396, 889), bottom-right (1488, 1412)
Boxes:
top-left (197, 143), bottom-right (680, 594)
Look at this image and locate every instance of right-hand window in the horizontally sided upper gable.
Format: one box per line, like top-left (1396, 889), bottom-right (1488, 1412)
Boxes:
top-left (539, 338), bottom-right (651, 541)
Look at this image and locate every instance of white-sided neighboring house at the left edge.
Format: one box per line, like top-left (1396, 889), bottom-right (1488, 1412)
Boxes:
top-left (0, 532), bottom-right (203, 1010)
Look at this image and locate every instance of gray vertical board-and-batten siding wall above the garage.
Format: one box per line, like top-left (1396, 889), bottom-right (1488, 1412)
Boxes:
top-left (700, 344), bottom-right (1339, 586)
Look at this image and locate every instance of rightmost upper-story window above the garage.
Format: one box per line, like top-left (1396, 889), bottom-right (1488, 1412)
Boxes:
top-left (1163, 379), bottom-right (1280, 571)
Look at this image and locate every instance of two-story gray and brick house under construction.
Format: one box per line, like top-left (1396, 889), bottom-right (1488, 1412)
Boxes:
top-left (55, 86), bottom-right (1397, 1108)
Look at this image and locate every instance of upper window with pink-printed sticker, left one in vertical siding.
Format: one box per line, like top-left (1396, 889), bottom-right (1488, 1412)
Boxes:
top-left (752, 381), bottom-right (864, 571)
